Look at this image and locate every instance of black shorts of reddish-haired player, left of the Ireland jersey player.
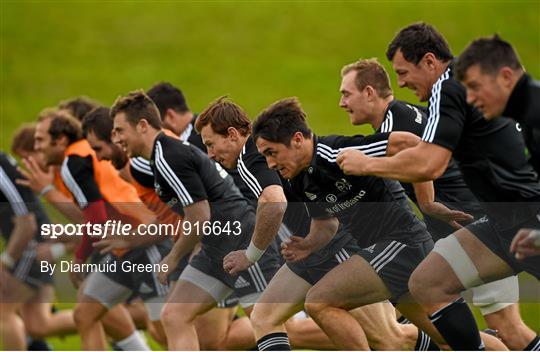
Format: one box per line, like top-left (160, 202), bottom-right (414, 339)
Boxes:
top-left (286, 238), bottom-right (360, 286)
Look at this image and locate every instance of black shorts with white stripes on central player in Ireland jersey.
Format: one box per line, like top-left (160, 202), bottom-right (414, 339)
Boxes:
top-left (355, 239), bottom-right (434, 304)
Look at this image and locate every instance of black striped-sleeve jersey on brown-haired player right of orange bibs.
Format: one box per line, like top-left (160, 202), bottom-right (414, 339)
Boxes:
top-left (150, 133), bottom-right (255, 257)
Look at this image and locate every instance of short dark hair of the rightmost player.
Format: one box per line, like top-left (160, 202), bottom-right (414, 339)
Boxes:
top-left (455, 34), bottom-right (523, 80)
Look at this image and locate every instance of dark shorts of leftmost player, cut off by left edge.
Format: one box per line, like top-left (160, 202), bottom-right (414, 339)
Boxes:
top-left (11, 241), bottom-right (53, 289)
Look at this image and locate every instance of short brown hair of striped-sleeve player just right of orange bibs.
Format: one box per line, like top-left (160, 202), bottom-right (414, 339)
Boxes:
top-left (111, 89), bottom-right (161, 130)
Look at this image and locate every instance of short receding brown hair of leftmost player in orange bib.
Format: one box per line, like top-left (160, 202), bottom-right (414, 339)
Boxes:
top-left (38, 108), bottom-right (82, 144)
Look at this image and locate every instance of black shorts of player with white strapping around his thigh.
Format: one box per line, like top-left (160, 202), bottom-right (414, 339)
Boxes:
top-left (467, 216), bottom-right (540, 280)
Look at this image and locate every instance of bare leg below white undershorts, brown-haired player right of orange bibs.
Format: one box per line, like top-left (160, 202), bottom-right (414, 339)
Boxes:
top-left (161, 279), bottom-right (216, 350)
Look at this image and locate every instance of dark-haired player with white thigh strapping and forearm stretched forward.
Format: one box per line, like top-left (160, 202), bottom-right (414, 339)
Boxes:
top-left (338, 23), bottom-right (540, 350)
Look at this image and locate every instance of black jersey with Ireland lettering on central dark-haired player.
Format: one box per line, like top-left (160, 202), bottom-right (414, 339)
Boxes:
top-left (291, 133), bottom-right (430, 247)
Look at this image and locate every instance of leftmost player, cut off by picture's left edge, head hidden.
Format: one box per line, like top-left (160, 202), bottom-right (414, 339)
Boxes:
top-left (0, 152), bottom-right (77, 350)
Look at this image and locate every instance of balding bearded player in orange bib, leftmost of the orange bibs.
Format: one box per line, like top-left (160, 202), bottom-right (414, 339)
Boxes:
top-left (31, 110), bottom-right (170, 349)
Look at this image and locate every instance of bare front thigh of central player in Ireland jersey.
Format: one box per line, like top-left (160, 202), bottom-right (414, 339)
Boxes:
top-left (306, 255), bottom-right (391, 310)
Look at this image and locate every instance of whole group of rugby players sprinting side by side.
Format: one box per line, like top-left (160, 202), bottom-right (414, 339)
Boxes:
top-left (0, 23), bottom-right (540, 350)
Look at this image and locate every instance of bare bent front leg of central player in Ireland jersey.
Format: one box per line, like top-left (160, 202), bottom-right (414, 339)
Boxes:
top-left (305, 255), bottom-right (390, 350)
